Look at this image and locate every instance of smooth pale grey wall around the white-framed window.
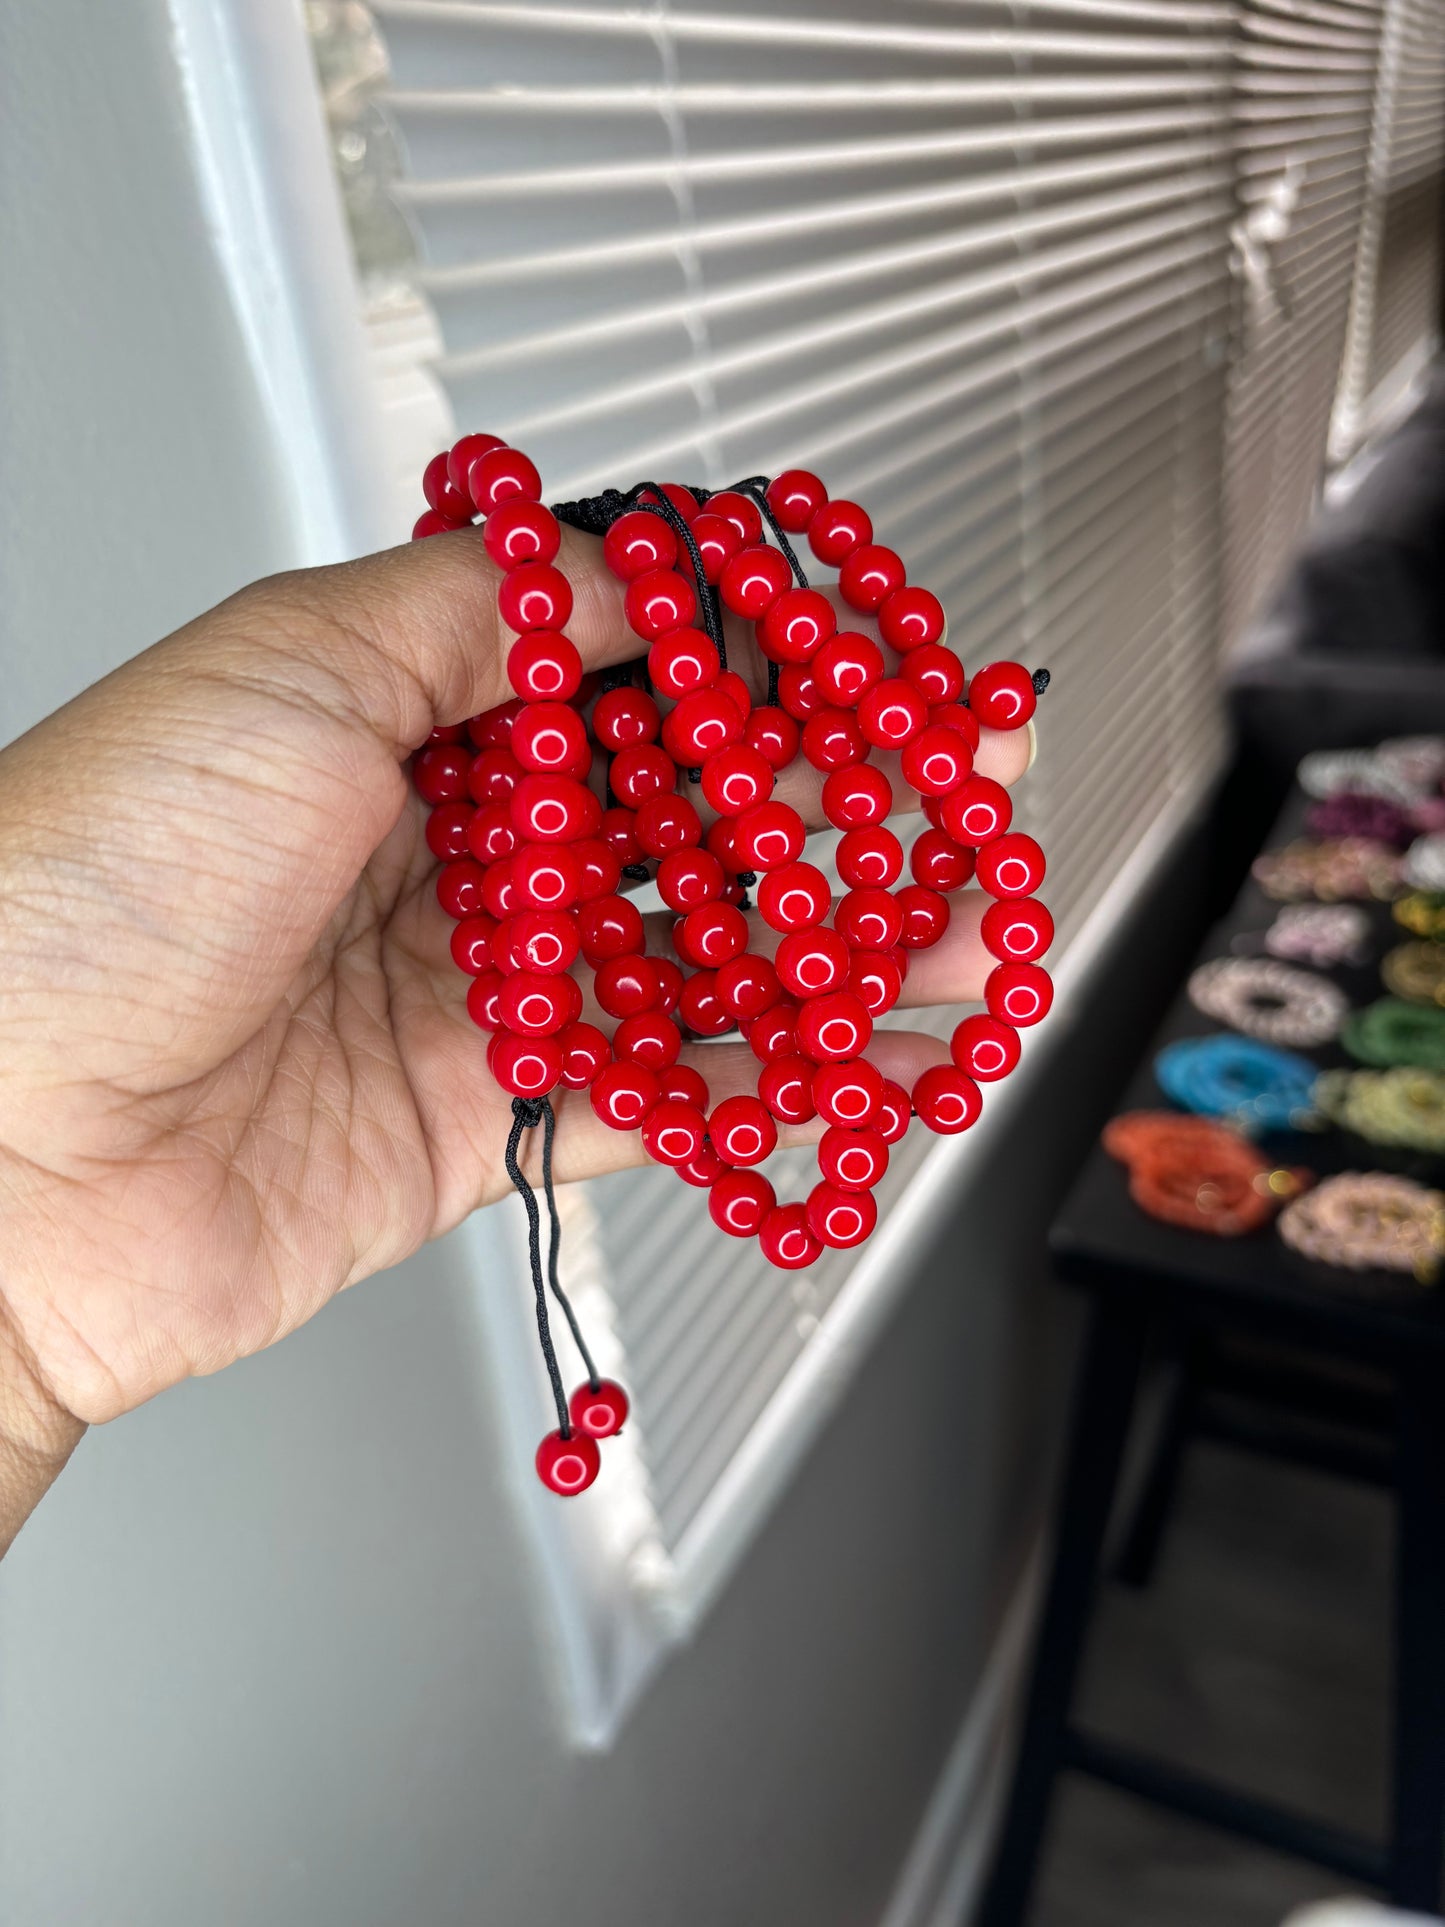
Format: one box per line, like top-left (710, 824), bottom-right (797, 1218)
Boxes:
top-left (0, 0), bottom-right (1179, 1927)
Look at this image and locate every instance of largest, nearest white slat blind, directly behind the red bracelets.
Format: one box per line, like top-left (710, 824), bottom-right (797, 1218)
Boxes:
top-left (364, 0), bottom-right (1256, 1545)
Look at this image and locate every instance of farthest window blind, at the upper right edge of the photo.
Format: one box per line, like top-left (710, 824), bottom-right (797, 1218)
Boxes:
top-left (1329, 0), bottom-right (1445, 461)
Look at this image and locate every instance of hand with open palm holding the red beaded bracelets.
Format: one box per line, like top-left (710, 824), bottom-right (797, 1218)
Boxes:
top-left (0, 532), bottom-right (1027, 1545)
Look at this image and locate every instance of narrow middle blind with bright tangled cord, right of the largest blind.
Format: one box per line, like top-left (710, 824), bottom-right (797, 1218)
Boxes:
top-left (1225, 0), bottom-right (1381, 640)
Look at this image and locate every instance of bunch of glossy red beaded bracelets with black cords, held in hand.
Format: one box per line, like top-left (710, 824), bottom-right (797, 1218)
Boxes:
top-left (412, 436), bottom-right (1054, 1493)
